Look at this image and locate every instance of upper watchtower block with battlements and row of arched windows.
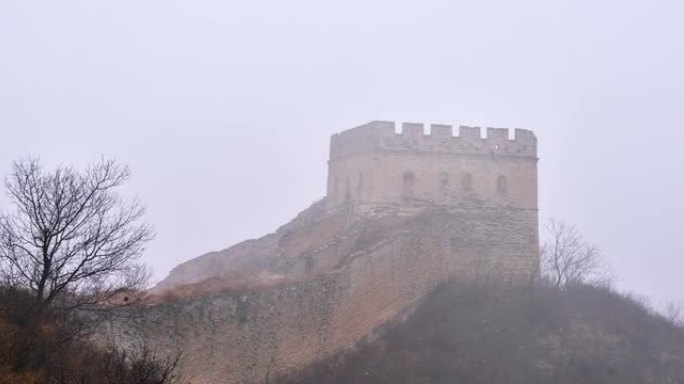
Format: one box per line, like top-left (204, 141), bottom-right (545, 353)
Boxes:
top-left (326, 121), bottom-right (537, 212)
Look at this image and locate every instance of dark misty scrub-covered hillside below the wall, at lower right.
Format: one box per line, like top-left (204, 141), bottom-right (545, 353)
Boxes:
top-left (278, 283), bottom-right (684, 384)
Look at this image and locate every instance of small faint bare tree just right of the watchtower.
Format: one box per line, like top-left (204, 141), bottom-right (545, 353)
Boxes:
top-left (540, 218), bottom-right (610, 287)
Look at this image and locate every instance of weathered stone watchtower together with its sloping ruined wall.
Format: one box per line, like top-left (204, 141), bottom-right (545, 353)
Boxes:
top-left (109, 122), bottom-right (538, 383)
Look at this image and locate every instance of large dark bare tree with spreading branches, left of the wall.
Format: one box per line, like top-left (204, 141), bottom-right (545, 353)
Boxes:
top-left (0, 159), bottom-right (153, 308)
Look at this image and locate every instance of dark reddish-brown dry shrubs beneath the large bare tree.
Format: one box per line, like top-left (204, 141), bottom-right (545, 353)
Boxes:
top-left (0, 287), bottom-right (179, 384)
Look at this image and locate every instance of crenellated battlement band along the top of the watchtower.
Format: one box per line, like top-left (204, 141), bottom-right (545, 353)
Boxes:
top-left (330, 121), bottom-right (537, 160)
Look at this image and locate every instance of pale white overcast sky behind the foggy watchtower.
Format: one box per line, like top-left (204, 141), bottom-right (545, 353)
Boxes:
top-left (0, 0), bottom-right (684, 305)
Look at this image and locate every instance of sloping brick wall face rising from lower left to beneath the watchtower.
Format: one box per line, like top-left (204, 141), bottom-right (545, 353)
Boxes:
top-left (109, 206), bottom-right (536, 383)
